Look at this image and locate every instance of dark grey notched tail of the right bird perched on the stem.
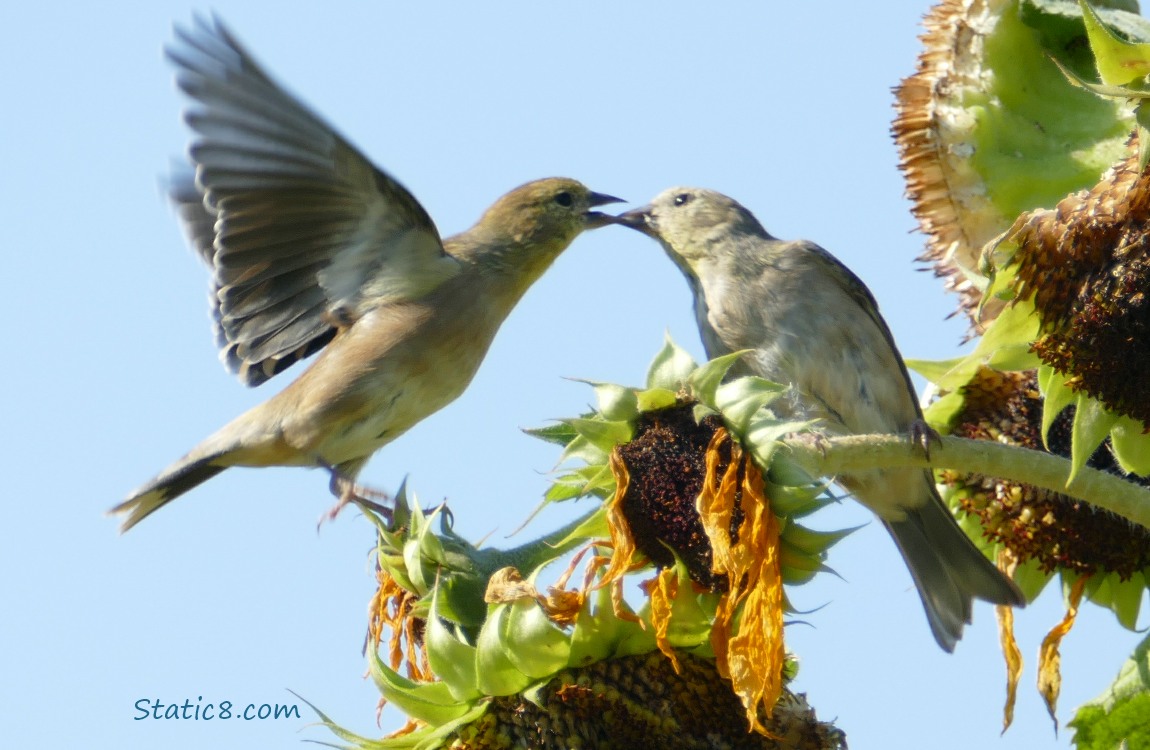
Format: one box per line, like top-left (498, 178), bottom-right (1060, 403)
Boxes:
top-left (884, 487), bottom-right (1026, 651)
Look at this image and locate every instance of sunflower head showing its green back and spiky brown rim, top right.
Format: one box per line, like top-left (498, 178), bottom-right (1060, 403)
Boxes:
top-left (892, 0), bottom-right (1136, 329)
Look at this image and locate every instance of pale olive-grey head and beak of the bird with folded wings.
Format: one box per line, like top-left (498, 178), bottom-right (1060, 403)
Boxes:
top-left (613, 188), bottom-right (769, 270)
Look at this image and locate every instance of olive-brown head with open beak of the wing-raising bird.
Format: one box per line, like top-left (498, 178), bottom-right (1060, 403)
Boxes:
top-left (477, 177), bottom-right (622, 253)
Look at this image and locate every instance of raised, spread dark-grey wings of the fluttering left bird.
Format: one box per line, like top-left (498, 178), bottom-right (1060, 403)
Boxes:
top-left (167, 18), bottom-right (459, 385)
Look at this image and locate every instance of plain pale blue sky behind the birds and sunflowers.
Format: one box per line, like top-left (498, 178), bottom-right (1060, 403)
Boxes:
top-left (0, 0), bottom-right (1139, 750)
